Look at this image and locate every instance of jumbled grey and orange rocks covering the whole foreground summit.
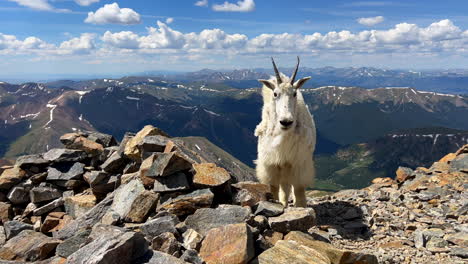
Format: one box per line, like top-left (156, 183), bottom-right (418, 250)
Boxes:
top-left (0, 126), bottom-right (468, 264)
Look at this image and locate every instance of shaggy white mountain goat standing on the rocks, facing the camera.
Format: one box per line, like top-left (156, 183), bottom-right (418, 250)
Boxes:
top-left (255, 57), bottom-right (316, 207)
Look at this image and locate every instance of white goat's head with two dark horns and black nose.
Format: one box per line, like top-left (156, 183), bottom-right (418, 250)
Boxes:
top-left (258, 57), bottom-right (310, 130)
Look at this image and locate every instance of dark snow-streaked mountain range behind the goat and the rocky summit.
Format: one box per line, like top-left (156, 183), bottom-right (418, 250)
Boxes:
top-left (0, 69), bottom-right (468, 189)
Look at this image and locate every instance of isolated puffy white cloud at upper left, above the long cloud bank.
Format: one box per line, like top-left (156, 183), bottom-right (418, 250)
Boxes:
top-left (84, 3), bottom-right (141, 25)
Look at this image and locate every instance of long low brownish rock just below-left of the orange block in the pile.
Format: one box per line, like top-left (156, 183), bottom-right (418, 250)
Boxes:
top-left (158, 189), bottom-right (214, 216)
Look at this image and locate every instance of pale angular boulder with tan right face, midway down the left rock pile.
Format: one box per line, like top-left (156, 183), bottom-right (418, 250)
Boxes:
top-left (111, 179), bottom-right (158, 222)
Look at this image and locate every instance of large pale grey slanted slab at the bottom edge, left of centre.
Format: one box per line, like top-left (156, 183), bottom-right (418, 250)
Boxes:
top-left (67, 228), bottom-right (148, 264)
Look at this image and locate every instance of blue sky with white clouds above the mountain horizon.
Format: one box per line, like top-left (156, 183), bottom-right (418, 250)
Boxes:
top-left (0, 0), bottom-right (468, 78)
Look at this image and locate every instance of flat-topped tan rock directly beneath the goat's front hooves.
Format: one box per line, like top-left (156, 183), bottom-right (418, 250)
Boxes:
top-left (268, 207), bottom-right (316, 233)
